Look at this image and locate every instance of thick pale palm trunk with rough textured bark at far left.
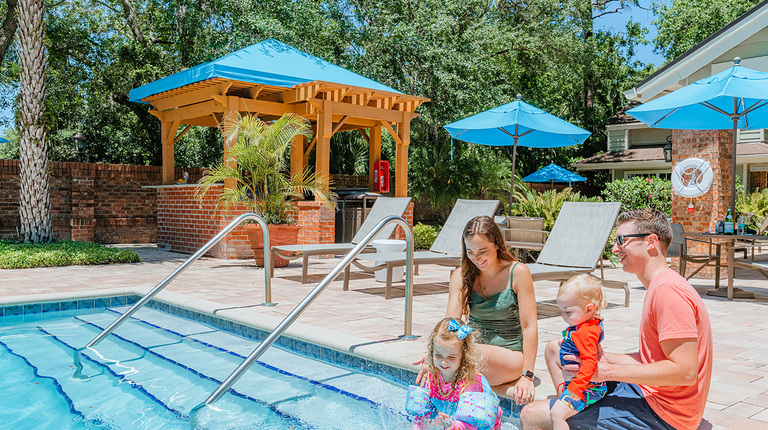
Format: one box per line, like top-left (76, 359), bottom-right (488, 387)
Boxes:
top-left (18, 0), bottom-right (53, 243)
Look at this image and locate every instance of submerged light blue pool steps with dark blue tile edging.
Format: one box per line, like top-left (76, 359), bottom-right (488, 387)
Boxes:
top-left (4, 308), bottom-right (405, 428)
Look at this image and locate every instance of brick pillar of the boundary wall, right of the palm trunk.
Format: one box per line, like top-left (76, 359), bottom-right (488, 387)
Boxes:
top-left (69, 163), bottom-right (96, 242)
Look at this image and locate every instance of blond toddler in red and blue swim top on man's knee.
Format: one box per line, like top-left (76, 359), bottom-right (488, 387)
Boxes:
top-left (550, 275), bottom-right (606, 430)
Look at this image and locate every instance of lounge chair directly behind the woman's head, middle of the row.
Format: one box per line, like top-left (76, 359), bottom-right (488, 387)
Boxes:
top-left (344, 199), bottom-right (499, 299)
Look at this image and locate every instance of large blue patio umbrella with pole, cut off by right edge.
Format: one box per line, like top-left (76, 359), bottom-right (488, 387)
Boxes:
top-left (627, 57), bottom-right (768, 218)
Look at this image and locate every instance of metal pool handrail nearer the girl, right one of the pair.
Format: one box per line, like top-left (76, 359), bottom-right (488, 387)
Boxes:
top-left (189, 216), bottom-right (416, 419)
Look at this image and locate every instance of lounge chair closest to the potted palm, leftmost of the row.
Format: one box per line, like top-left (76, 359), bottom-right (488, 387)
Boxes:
top-left (270, 197), bottom-right (411, 284)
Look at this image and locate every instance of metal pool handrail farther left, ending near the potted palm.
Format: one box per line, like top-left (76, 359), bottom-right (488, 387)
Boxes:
top-left (74, 213), bottom-right (275, 378)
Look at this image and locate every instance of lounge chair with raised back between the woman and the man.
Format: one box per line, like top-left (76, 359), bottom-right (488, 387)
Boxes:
top-left (528, 202), bottom-right (629, 307)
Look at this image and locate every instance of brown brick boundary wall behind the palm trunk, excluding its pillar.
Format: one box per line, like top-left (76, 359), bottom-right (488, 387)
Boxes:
top-left (0, 160), bottom-right (202, 243)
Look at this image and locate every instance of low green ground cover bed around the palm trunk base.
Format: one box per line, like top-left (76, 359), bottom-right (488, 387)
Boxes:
top-left (0, 240), bottom-right (141, 269)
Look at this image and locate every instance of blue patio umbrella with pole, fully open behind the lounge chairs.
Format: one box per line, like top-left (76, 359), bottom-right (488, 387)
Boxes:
top-left (443, 94), bottom-right (592, 202)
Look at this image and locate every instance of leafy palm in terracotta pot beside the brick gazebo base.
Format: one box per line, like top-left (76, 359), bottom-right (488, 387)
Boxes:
top-left (196, 113), bottom-right (336, 267)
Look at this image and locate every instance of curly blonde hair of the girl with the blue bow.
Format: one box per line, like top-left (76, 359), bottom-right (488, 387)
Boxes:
top-left (427, 318), bottom-right (480, 391)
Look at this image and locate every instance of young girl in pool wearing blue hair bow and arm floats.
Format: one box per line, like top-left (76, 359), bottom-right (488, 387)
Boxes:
top-left (406, 318), bottom-right (501, 430)
